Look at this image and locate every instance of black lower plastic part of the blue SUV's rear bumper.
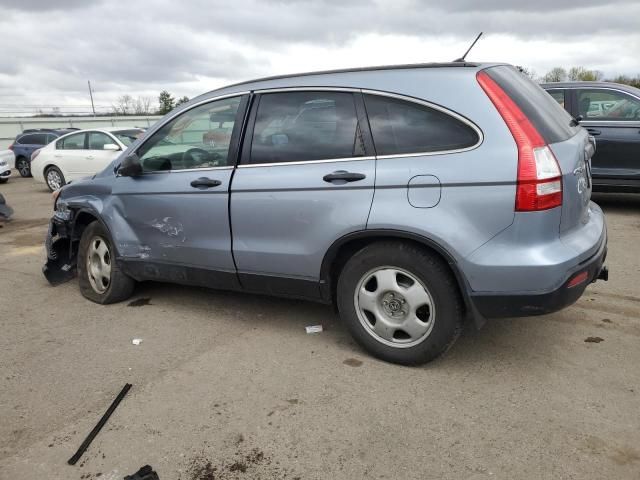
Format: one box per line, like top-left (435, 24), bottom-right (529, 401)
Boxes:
top-left (471, 232), bottom-right (607, 318)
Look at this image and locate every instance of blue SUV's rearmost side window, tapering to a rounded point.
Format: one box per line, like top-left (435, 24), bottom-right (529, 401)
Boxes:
top-left (364, 94), bottom-right (480, 155)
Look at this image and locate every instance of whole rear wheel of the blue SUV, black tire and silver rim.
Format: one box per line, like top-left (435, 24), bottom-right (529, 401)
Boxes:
top-left (337, 241), bottom-right (463, 365)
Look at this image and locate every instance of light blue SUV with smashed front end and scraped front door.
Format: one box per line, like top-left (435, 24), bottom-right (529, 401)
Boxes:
top-left (44, 62), bottom-right (607, 364)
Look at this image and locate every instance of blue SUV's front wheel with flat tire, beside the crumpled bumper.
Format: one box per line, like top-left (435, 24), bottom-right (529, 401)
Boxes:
top-left (78, 221), bottom-right (135, 304)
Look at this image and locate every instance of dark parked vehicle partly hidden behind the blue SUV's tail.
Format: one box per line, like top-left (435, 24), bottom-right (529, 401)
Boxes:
top-left (542, 82), bottom-right (640, 192)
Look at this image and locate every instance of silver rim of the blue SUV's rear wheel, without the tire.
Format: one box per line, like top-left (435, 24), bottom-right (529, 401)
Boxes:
top-left (354, 267), bottom-right (435, 348)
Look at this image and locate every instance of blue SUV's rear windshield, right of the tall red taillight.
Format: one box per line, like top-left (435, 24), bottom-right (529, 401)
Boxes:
top-left (484, 66), bottom-right (580, 143)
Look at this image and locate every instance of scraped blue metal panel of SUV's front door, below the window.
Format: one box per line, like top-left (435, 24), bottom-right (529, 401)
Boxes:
top-left (112, 167), bottom-right (235, 276)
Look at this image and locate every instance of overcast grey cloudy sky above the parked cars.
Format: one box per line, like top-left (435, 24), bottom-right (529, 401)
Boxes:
top-left (0, 0), bottom-right (640, 113)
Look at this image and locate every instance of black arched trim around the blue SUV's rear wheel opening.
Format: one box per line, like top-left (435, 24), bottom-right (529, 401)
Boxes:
top-left (323, 235), bottom-right (468, 316)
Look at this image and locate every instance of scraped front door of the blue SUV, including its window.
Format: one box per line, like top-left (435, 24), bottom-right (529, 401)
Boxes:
top-left (111, 96), bottom-right (246, 280)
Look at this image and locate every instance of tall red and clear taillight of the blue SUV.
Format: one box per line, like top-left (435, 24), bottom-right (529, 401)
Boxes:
top-left (477, 72), bottom-right (562, 212)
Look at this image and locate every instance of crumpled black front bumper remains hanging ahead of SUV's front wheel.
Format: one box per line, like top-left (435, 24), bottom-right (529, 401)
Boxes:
top-left (42, 217), bottom-right (77, 286)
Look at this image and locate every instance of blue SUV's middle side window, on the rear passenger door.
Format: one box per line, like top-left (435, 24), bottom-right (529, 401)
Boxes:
top-left (251, 92), bottom-right (364, 163)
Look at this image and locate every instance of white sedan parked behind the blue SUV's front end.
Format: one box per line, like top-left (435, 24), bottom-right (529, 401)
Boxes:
top-left (31, 127), bottom-right (144, 191)
